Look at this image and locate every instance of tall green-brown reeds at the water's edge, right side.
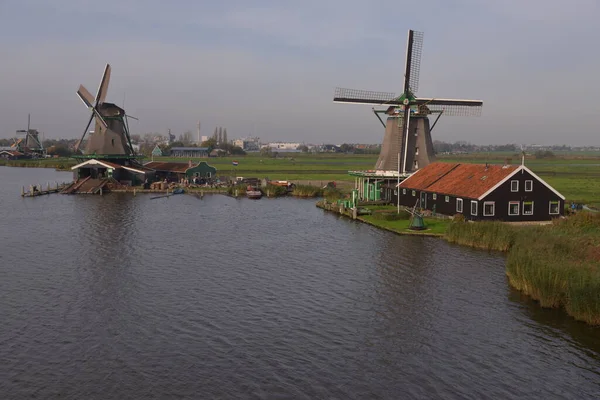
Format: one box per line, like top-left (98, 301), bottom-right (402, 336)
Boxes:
top-left (506, 213), bottom-right (600, 325)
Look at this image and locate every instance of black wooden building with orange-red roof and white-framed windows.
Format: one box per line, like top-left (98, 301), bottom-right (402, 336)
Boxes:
top-left (392, 162), bottom-right (565, 221)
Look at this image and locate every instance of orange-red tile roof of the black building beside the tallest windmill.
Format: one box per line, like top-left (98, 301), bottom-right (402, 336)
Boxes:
top-left (400, 162), bottom-right (519, 199)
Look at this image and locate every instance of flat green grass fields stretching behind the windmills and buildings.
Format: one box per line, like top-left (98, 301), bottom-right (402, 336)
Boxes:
top-left (0, 153), bottom-right (600, 208)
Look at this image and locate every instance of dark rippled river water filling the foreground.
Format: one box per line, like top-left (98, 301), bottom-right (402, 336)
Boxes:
top-left (0, 167), bottom-right (600, 399)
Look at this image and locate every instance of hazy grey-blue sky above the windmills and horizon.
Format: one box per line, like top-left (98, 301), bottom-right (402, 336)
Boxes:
top-left (0, 0), bottom-right (600, 146)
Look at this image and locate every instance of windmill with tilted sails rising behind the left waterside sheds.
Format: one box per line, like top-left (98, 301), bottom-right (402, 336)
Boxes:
top-left (75, 64), bottom-right (137, 159)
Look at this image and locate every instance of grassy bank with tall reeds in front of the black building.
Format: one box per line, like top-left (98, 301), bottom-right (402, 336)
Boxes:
top-left (317, 202), bottom-right (600, 325)
